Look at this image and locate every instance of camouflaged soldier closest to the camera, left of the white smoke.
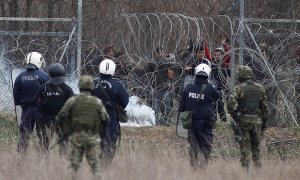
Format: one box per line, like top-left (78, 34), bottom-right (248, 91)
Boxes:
top-left (56, 76), bottom-right (109, 178)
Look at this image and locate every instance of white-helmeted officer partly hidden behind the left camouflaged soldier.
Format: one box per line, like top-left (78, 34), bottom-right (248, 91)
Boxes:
top-left (92, 59), bottom-right (129, 165)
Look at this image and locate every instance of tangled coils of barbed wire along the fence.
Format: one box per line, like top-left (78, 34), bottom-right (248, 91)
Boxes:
top-left (1, 4), bottom-right (300, 125)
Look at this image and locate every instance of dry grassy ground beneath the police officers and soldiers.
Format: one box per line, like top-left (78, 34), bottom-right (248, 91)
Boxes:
top-left (0, 116), bottom-right (300, 180)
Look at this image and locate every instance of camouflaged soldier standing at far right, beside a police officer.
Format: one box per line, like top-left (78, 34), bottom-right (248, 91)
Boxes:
top-left (228, 65), bottom-right (268, 170)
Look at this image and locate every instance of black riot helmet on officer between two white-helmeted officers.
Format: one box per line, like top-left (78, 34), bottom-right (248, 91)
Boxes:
top-left (49, 63), bottom-right (66, 85)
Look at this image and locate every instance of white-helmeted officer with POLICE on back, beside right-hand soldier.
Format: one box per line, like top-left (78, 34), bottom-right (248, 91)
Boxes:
top-left (178, 64), bottom-right (220, 168)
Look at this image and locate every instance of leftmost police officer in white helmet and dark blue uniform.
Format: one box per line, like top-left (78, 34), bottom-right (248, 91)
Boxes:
top-left (13, 52), bottom-right (49, 153)
